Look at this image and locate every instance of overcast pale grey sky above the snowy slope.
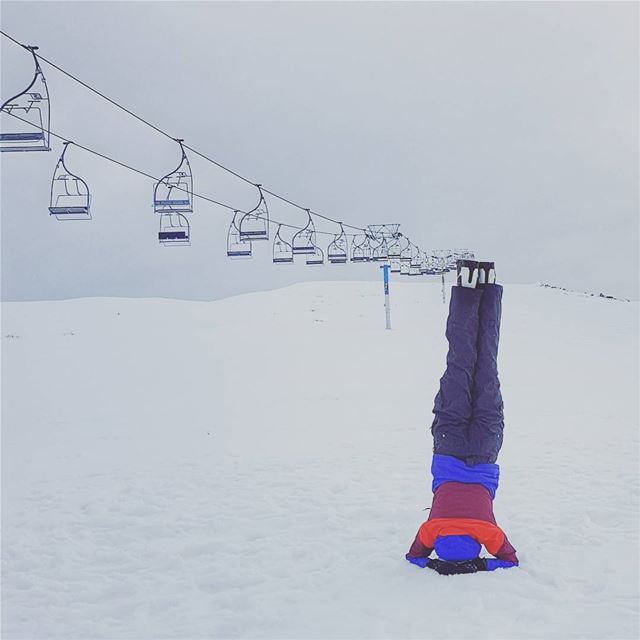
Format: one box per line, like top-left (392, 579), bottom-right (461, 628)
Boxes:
top-left (0, 0), bottom-right (640, 300)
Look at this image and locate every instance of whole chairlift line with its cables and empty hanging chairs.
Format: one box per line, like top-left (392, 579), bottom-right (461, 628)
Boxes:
top-left (0, 30), bottom-right (476, 275)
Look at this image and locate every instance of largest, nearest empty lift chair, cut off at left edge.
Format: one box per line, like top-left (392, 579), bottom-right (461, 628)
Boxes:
top-left (0, 47), bottom-right (51, 151)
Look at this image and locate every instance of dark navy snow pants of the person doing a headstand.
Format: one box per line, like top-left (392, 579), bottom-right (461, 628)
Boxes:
top-left (431, 284), bottom-right (504, 465)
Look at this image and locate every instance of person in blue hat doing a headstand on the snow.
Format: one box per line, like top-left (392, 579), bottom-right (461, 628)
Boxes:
top-left (406, 260), bottom-right (518, 575)
